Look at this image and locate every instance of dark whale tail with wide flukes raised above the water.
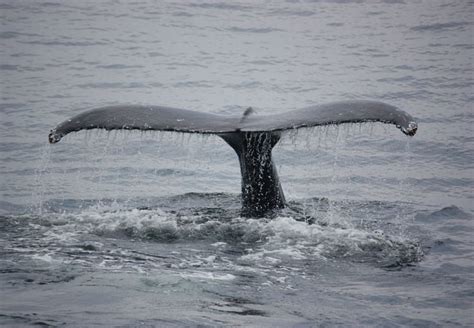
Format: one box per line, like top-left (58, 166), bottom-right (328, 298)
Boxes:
top-left (49, 101), bottom-right (418, 216)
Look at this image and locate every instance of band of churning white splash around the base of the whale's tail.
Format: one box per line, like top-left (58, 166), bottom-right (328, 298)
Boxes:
top-left (7, 205), bottom-right (423, 272)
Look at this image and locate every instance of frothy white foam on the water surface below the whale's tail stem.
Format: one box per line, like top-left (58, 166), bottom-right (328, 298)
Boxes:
top-left (32, 205), bottom-right (418, 272)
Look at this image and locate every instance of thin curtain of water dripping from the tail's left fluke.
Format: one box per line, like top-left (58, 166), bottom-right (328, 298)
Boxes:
top-left (33, 131), bottom-right (240, 211)
